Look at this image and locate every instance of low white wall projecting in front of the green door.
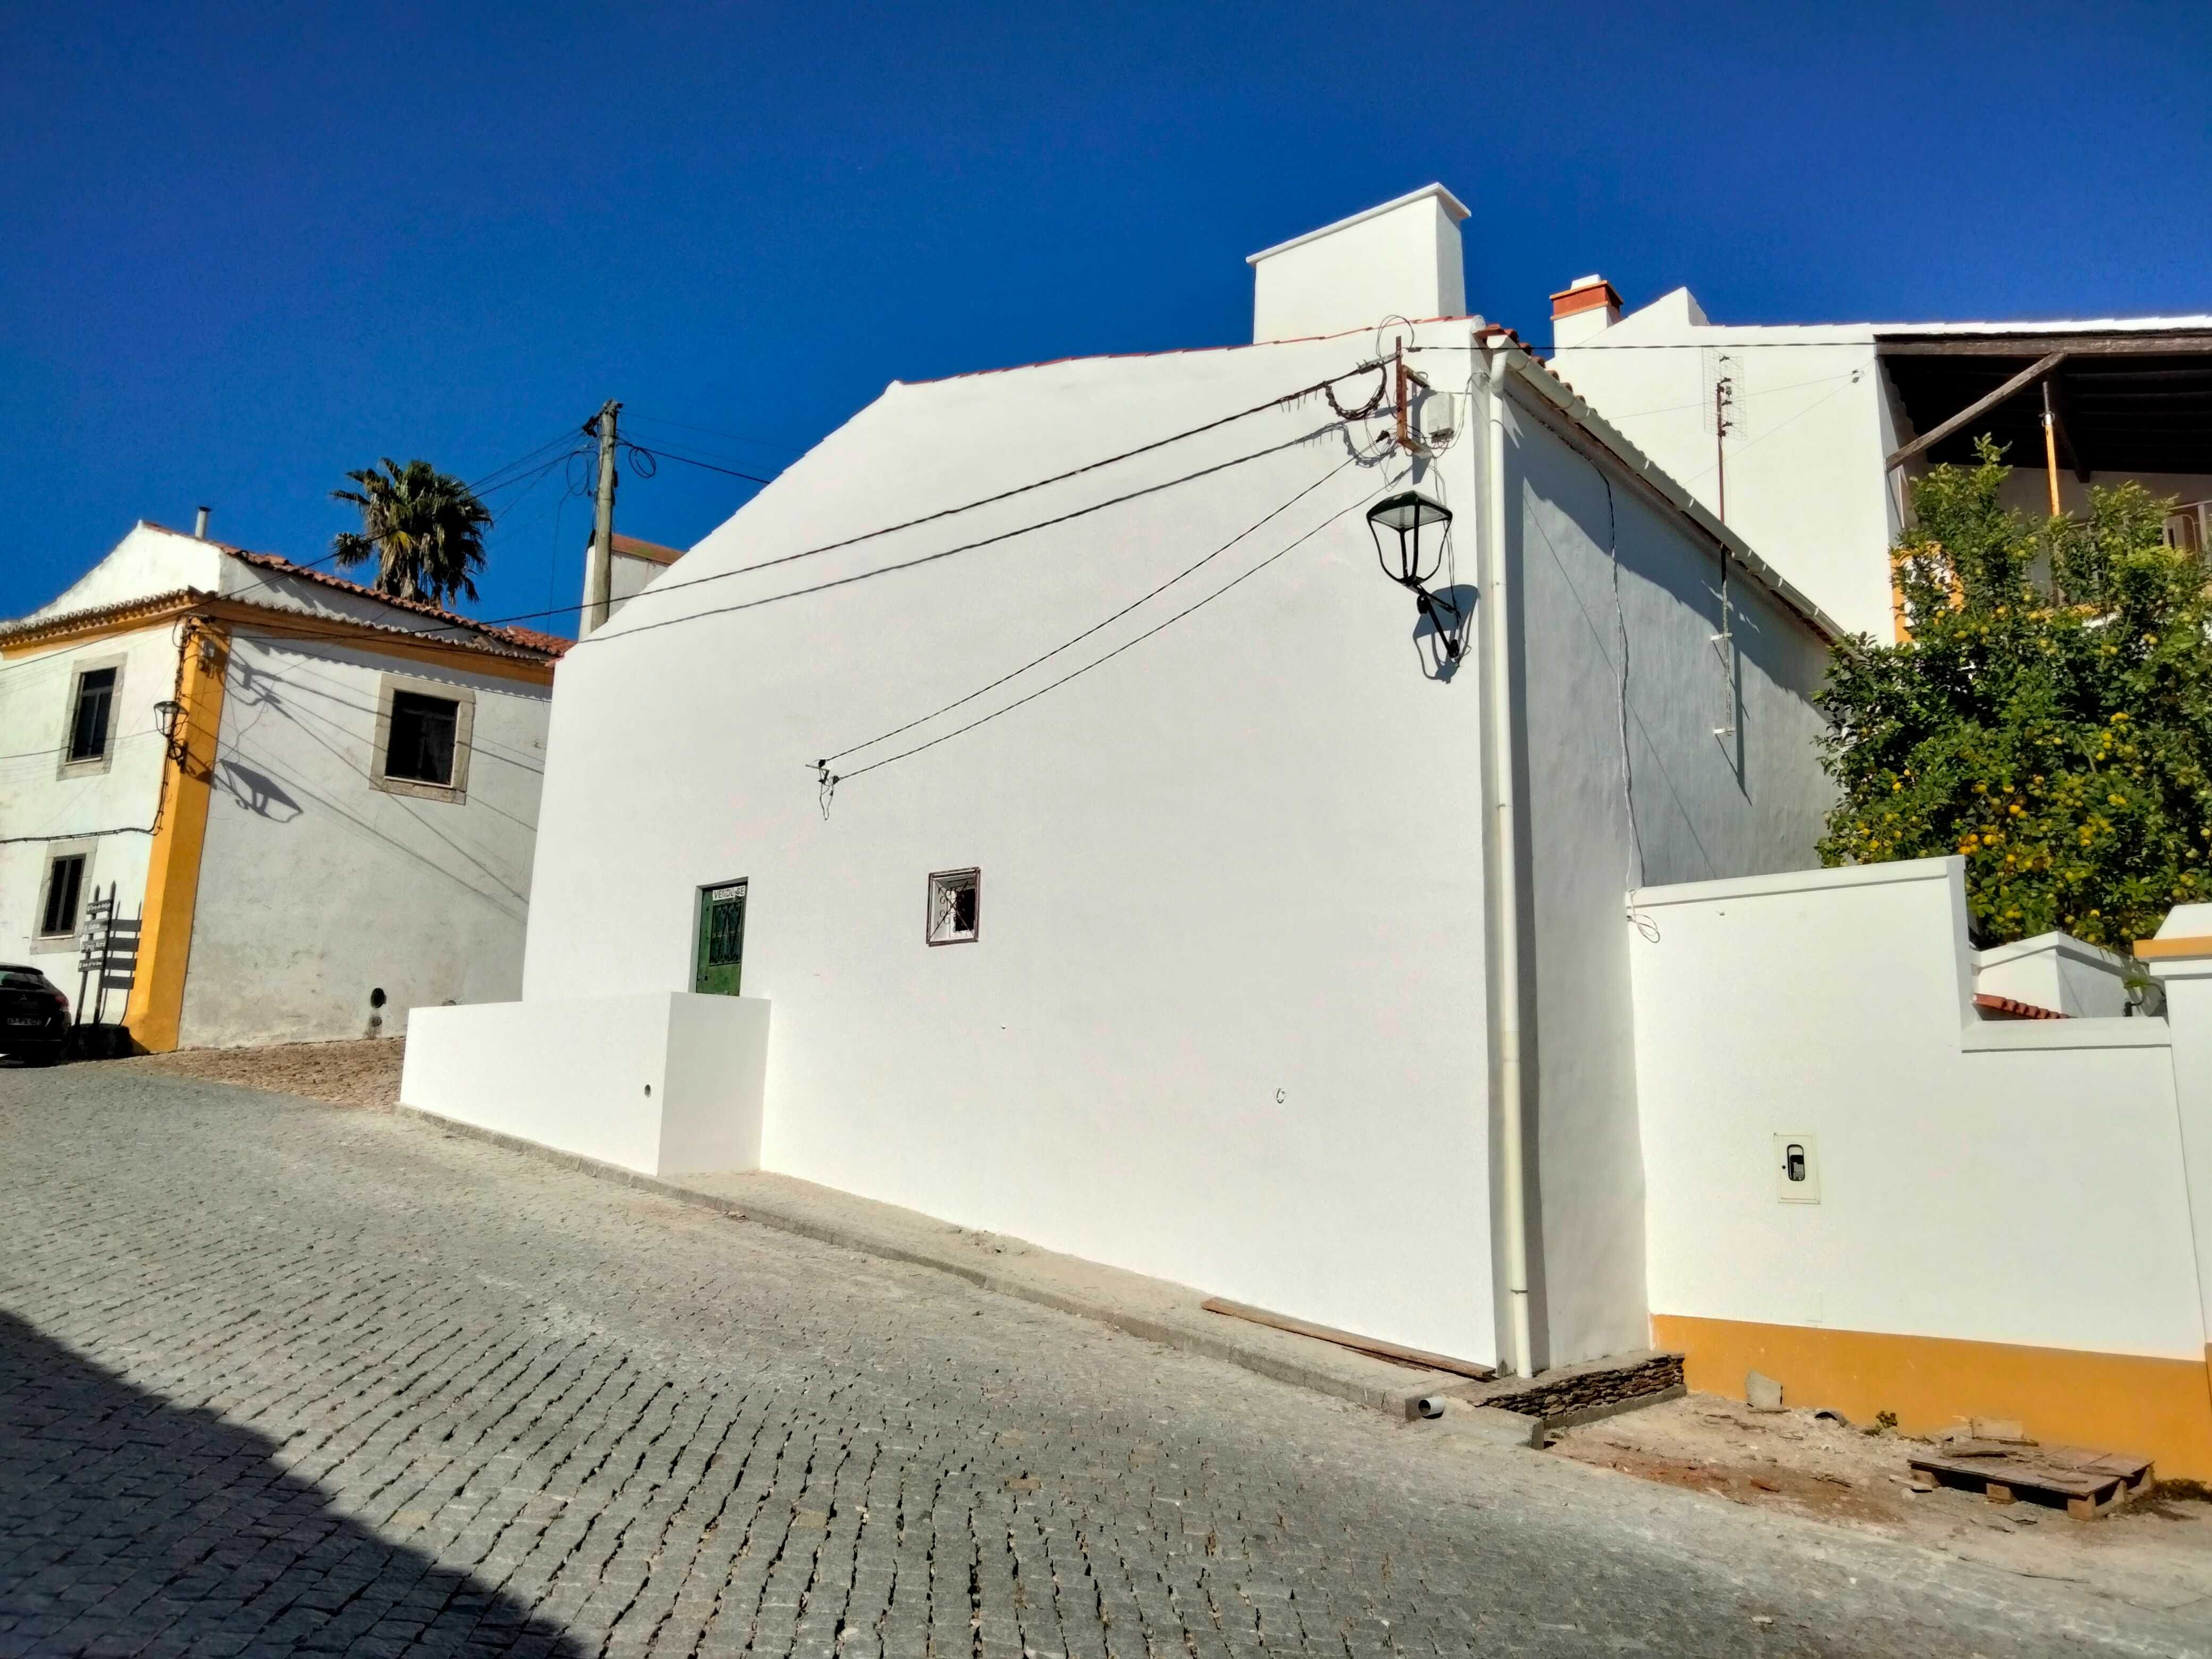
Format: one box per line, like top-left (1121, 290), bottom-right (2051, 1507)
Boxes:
top-left (400, 991), bottom-right (768, 1175)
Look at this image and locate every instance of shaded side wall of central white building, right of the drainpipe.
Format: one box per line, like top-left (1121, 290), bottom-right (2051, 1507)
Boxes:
top-left (1506, 393), bottom-right (1834, 1363)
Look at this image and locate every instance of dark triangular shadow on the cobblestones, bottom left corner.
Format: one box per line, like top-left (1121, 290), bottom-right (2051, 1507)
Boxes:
top-left (0, 1314), bottom-right (582, 1655)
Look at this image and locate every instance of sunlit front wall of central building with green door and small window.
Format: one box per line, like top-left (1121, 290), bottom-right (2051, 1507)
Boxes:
top-left (526, 330), bottom-right (1495, 1358)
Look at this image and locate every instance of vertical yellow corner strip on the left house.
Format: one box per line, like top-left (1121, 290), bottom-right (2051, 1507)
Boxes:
top-left (124, 626), bottom-right (230, 1055)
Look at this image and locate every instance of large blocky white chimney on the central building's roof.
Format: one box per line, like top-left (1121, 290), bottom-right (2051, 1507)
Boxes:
top-left (1245, 183), bottom-right (1467, 343)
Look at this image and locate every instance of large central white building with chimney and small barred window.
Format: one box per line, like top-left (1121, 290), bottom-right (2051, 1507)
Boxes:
top-left (403, 188), bottom-right (1836, 1369)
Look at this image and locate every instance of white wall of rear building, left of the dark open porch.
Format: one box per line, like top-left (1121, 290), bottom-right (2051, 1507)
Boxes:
top-left (1551, 312), bottom-right (1896, 641)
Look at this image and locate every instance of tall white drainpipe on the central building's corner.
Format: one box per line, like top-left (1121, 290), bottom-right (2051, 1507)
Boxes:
top-left (1482, 334), bottom-right (1535, 1376)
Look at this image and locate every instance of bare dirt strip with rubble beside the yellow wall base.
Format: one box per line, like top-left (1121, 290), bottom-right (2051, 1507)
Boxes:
top-left (1553, 1394), bottom-right (2212, 1608)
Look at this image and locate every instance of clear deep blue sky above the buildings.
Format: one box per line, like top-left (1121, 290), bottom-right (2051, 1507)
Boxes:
top-left (0, 0), bottom-right (2212, 633)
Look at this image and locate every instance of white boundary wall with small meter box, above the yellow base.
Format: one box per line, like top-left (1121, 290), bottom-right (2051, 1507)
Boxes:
top-left (1623, 858), bottom-right (2206, 1360)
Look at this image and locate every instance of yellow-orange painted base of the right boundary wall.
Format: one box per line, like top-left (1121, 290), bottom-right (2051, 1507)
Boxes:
top-left (1653, 1314), bottom-right (2212, 1480)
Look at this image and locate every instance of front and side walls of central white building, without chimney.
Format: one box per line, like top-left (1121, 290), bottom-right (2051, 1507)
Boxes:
top-left (524, 325), bottom-right (1827, 1363)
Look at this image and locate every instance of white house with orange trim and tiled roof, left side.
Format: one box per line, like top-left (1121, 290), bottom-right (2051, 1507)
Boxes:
top-left (0, 522), bottom-right (568, 1051)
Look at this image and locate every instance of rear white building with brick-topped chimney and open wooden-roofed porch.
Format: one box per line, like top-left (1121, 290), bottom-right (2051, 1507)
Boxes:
top-left (1551, 276), bottom-right (2212, 641)
